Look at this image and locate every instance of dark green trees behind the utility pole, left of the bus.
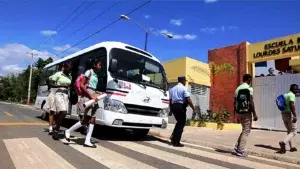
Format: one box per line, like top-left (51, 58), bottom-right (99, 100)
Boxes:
top-left (0, 58), bottom-right (53, 103)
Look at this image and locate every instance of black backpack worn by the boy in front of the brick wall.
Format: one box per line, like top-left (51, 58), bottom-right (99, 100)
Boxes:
top-left (236, 89), bottom-right (250, 114)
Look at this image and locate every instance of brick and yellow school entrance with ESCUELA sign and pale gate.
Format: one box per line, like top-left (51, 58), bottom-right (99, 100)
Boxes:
top-left (208, 34), bottom-right (300, 129)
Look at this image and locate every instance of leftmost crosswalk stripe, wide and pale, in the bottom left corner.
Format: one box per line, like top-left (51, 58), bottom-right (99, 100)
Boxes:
top-left (3, 137), bottom-right (75, 169)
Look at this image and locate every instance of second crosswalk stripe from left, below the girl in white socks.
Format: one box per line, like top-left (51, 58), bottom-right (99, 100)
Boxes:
top-left (61, 139), bottom-right (156, 169)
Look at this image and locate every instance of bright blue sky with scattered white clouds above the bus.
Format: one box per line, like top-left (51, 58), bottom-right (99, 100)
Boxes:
top-left (0, 0), bottom-right (300, 75)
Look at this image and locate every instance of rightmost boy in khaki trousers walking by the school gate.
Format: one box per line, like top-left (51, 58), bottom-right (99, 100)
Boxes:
top-left (279, 84), bottom-right (298, 154)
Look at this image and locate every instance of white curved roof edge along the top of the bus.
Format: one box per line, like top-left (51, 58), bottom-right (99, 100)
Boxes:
top-left (44, 41), bottom-right (160, 69)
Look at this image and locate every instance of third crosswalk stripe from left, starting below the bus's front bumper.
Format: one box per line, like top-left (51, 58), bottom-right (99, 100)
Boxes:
top-left (109, 141), bottom-right (229, 169)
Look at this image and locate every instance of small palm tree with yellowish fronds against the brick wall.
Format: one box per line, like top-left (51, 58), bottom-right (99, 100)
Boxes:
top-left (208, 62), bottom-right (234, 111)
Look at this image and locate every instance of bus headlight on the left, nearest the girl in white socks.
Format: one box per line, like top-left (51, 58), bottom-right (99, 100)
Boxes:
top-left (104, 98), bottom-right (128, 113)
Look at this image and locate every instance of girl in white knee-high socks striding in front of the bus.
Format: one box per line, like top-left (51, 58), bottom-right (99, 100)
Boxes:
top-left (65, 59), bottom-right (102, 148)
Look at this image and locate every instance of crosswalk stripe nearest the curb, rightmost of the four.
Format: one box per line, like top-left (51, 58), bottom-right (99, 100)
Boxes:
top-left (147, 141), bottom-right (280, 169)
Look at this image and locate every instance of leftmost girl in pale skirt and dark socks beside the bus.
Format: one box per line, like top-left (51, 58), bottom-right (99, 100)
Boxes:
top-left (51, 63), bottom-right (71, 140)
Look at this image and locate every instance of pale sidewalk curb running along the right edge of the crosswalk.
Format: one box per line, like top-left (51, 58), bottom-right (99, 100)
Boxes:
top-left (149, 130), bottom-right (300, 165)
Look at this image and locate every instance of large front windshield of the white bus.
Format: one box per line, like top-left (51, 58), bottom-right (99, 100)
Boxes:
top-left (110, 48), bottom-right (167, 90)
